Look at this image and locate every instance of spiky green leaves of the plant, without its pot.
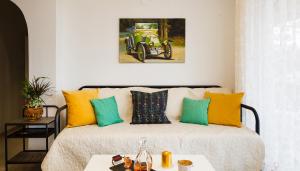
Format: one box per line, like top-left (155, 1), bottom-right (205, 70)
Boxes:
top-left (22, 77), bottom-right (52, 108)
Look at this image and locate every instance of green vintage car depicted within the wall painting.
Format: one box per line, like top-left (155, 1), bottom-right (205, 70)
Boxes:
top-left (125, 23), bottom-right (172, 62)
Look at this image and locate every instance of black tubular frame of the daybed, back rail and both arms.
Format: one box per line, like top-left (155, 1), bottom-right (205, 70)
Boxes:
top-left (55, 85), bottom-right (260, 134)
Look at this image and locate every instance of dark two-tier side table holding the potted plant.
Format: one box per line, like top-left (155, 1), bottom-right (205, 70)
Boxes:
top-left (4, 105), bottom-right (58, 171)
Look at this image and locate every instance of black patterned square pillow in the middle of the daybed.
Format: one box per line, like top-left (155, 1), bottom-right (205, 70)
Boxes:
top-left (131, 90), bottom-right (171, 124)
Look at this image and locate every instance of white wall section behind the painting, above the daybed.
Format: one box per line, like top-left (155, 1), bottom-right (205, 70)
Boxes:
top-left (56, 0), bottom-right (235, 89)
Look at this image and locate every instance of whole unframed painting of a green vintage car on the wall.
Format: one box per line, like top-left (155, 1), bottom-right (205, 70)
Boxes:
top-left (119, 18), bottom-right (185, 63)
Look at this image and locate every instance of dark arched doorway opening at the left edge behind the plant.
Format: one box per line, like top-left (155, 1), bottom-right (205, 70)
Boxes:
top-left (0, 0), bottom-right (28, 133)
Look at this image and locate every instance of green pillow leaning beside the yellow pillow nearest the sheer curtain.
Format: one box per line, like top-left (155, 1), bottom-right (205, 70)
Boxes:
top-left (180, 98), bottom-right (210, 125)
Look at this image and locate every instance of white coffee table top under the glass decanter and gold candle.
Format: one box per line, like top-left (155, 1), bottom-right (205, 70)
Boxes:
top-left (84, 155), bottom-right (215, 171)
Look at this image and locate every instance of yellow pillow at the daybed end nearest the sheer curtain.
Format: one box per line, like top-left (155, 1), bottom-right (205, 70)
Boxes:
top-left (204, 92), bottom-right (244, 127)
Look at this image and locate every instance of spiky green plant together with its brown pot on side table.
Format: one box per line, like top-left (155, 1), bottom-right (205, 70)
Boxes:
top-left (22, 77), bottom-right (52, 121)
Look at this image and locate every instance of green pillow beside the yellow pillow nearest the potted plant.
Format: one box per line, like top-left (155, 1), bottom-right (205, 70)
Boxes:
top-left (91, 96), bottom-right (123, 127)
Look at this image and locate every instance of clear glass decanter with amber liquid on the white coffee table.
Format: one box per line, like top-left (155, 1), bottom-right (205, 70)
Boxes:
top-left (134, 137), bottom-right (152, 171)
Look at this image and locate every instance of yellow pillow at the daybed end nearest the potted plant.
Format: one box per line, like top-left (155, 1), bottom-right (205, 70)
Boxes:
top-left (63, 89), bottom-right (99, 127)
